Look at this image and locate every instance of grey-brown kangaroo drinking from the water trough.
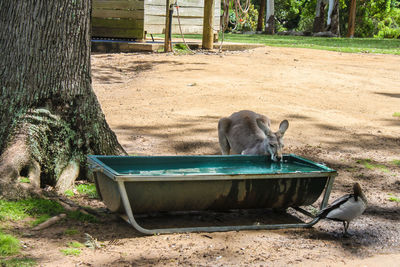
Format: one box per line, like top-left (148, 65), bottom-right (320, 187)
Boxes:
top-left (218, 110), bottom-right (289, 161)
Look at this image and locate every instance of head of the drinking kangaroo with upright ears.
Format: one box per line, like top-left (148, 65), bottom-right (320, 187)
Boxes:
top-left (257, 119), bottom-right (289, 161)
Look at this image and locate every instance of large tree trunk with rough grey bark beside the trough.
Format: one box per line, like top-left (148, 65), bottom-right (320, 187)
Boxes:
top-left (0, 0), bottom-right (125, 198)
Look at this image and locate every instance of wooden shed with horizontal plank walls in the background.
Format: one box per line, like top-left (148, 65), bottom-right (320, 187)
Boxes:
top-left (92, 0), bottom-right (221, 40)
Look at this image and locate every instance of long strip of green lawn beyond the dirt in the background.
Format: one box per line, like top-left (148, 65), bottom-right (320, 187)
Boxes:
top-left (164, 33), bottom-right (400, 55)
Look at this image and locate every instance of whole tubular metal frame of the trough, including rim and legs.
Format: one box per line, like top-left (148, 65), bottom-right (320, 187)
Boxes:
top-left (88, 154), bottom-right (337, 235)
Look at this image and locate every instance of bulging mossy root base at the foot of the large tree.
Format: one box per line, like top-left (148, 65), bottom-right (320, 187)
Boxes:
top-left (0, 109), bottom-right (81, 199)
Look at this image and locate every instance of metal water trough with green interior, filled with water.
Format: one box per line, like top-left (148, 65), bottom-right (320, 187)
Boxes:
top-left (88, 154), bottom-right (337, 234)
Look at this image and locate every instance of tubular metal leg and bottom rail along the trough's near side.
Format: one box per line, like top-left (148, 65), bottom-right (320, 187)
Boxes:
top-left (118, 176), bottom-right (335, 235)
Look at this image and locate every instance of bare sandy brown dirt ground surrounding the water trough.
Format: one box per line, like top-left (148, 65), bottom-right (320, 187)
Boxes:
top-left (14, 47), bottom-right (400, 267)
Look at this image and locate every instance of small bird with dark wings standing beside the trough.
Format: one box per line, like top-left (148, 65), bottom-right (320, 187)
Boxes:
top-left (316, 183), bottom-right (368, 236)
